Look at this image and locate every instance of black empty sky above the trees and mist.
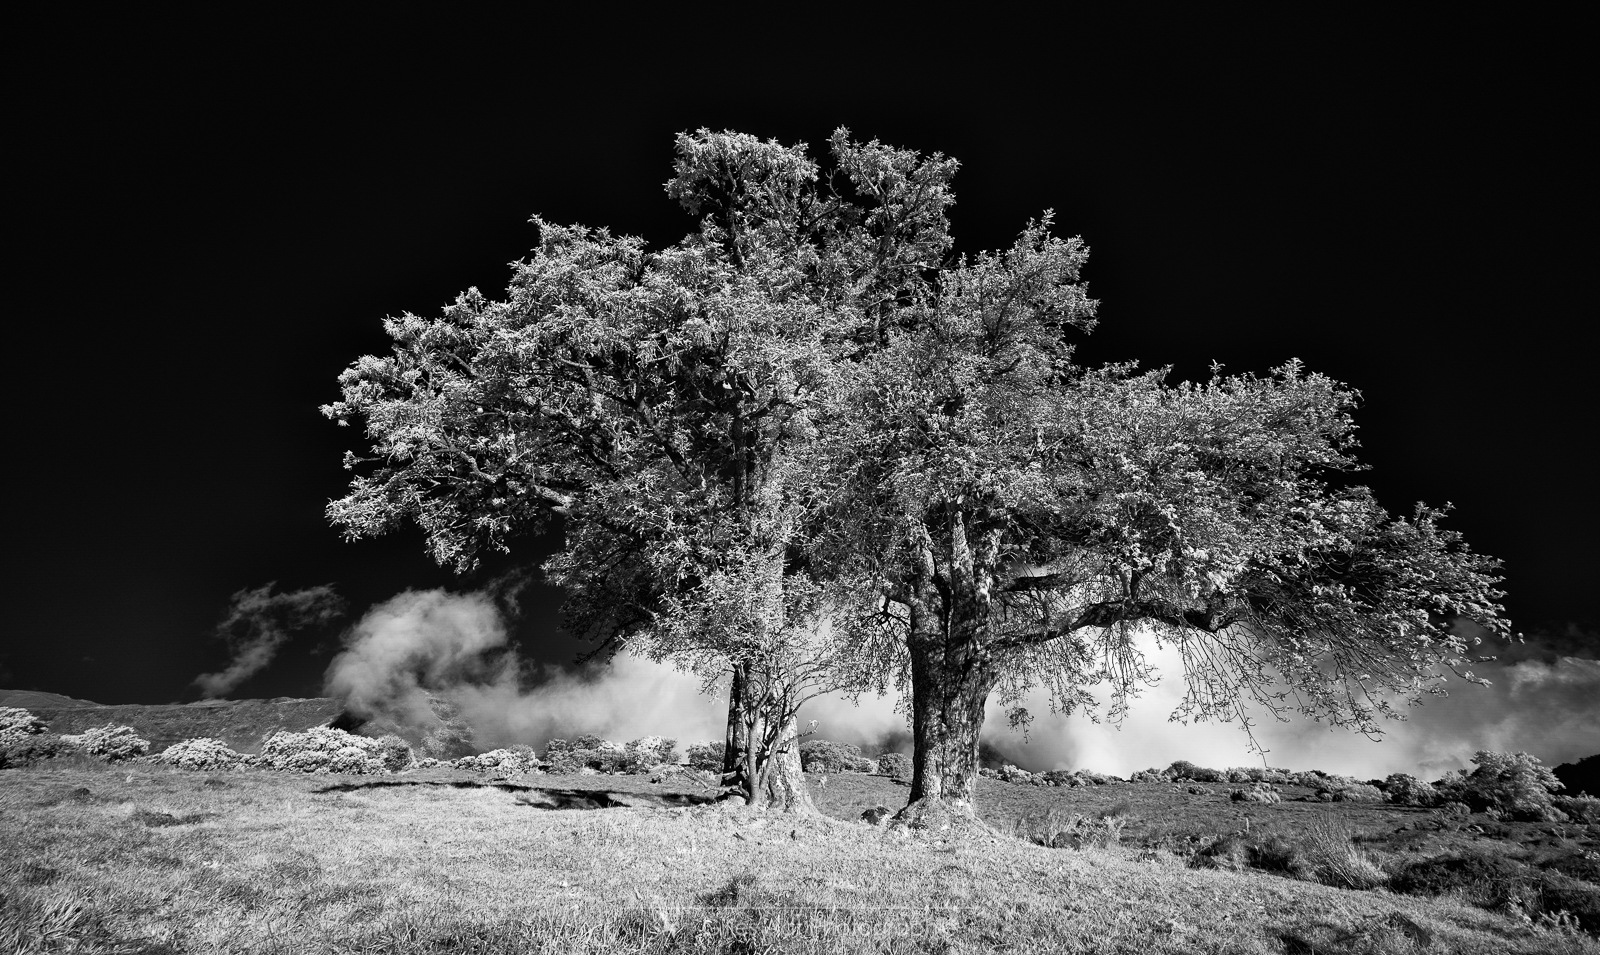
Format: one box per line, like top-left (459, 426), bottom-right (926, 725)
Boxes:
top-left (0, 8), bottom-right (1600, 702)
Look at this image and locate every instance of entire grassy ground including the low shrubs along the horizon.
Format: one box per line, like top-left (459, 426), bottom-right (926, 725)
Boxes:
top-left (0, 710), bottom-right (1600, 955)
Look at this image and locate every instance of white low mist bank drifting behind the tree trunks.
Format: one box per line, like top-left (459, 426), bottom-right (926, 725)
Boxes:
top-left (326, 590), bottom-right (1600, 779)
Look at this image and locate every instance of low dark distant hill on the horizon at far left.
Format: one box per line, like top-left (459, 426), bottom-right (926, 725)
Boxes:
top-left (0, 689), bottom-right (342, 753)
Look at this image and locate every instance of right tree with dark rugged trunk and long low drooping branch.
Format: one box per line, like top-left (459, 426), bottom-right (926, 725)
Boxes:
top-left (821, 214), bottom-right (1507, 817)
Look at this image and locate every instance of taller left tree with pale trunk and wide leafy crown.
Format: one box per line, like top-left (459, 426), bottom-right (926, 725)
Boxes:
top-left (325, 130), bottom-right (955, 809)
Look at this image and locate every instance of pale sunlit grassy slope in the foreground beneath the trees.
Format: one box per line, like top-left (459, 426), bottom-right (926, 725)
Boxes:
top-left (0, 761), bottom-right (1595, 955)
